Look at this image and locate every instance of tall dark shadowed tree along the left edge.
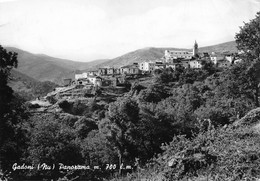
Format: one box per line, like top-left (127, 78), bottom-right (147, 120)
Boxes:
top-left (0, 46), bottom-right (26, 170)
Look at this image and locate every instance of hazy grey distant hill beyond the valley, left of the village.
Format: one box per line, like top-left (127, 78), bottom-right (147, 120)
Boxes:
top-left (6, 47), bottom-right (106, 84)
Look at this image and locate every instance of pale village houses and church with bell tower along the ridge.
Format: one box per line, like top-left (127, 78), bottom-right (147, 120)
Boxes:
top-left (65, 41), bottom-right (242, 86)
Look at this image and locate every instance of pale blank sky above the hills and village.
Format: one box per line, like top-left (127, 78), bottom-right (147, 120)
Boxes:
top-left (0, 0), bottom-right (260, 61)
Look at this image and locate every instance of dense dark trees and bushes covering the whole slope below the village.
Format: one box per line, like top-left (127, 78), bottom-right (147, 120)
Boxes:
top-left (0, 13), bottom-right (260, 180)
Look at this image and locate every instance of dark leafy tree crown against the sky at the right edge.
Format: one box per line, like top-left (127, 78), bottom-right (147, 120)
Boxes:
top-left (235, 12), bottom-right (260, 60)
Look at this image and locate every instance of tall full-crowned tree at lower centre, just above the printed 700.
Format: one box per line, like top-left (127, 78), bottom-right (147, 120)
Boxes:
top-left (99, 97), bottom-right (139, 173)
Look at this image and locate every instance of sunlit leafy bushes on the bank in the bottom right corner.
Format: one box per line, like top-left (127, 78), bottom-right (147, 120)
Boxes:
top-left (114, 127), bottom-right (260, 181)
